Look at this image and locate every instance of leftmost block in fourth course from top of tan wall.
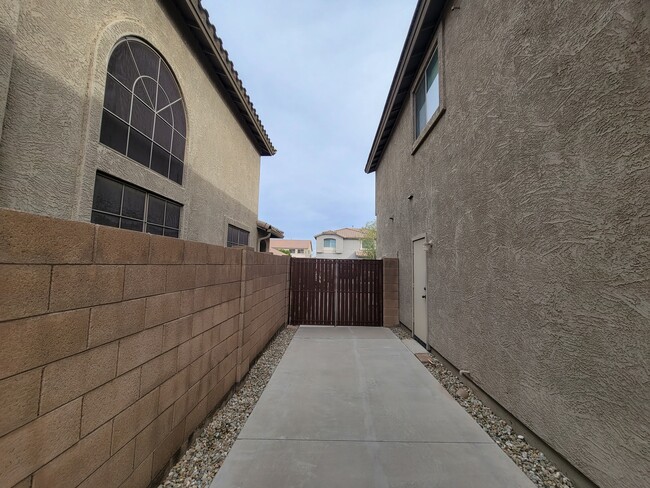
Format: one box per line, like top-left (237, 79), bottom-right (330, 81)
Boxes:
top-left (0, 369), bottom-right (41, 436)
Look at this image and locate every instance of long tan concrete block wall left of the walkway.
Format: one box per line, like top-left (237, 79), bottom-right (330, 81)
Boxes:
top-left (0, 209), bottom-right (289, 488)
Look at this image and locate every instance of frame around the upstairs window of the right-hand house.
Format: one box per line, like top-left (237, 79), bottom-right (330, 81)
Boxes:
top-left (411, 30), bottom-right (445, 155)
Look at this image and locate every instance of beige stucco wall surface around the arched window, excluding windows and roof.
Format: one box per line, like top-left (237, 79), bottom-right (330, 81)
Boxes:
top-left (0, 0), bottom-right (260, 245)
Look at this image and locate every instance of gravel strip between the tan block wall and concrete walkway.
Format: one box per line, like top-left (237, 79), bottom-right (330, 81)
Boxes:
top-left (158, 326), bottom-right (297, 488)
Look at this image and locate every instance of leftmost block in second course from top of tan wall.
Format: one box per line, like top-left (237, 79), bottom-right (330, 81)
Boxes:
top-left (0, 264), bottom-right (51, 322)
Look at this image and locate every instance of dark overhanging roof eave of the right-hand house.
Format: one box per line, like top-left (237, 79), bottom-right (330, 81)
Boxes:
top-left (365, 0), bottom-right (445, 173)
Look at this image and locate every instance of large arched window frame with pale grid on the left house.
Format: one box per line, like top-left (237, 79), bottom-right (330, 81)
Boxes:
top-left (98, 36), bottom-right (189, 187)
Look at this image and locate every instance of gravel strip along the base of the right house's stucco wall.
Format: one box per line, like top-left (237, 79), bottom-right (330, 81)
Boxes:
top-left (391, 326), bottom-right (574, 488)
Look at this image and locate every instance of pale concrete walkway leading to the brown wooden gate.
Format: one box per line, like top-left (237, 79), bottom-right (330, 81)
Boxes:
top-left (211, 326), bottom-right (533, 488)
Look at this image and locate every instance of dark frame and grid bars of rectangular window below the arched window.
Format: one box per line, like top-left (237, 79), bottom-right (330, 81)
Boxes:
top-left (90, 171), bottom-right (183, 238)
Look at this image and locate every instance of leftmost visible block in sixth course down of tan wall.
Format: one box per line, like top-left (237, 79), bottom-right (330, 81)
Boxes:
top-left (32, 422), bottom-right (111, 488)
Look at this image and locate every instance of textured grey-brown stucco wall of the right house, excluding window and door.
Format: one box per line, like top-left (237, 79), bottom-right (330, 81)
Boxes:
top-left (376, 0), bottom-right (650, 488)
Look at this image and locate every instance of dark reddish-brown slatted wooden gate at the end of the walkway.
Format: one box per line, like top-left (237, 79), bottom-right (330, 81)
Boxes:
top-left (289, 258), bottom-right (383, 326)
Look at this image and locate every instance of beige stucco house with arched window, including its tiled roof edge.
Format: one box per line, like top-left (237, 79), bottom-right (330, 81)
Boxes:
top-left (0, 0), bottom-right (275, 248)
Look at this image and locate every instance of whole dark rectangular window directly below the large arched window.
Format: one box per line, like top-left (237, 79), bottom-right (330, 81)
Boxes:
top-left (90, 173), bottom-right (181, 237)
